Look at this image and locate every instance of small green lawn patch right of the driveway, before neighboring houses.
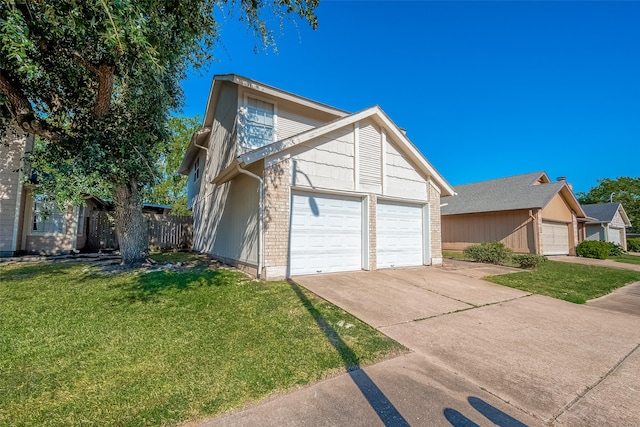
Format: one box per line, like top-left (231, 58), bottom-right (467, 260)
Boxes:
top-left (484, 261), bottom-right (640, 304)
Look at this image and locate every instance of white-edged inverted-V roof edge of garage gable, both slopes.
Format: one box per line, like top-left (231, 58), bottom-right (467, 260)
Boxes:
top-left (213, 105), bottom-right (455, 196)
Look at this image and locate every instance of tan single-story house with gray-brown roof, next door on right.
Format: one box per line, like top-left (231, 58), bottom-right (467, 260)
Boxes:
top-left (442, 172), bottom-right (585, 255)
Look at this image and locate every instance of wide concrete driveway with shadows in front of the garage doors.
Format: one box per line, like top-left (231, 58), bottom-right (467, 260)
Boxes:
top-left (201, 266), bottom-right (640, 426)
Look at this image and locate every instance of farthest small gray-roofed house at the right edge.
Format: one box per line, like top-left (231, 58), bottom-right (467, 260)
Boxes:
top-left (582, 203), bottom-right (631, 251)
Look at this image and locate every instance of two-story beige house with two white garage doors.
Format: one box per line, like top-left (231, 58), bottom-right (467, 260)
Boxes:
top-left (179, 74), bottom-right (453, 279)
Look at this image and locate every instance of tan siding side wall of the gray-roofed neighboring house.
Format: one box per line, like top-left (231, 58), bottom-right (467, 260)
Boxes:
top-left (442, 210), bottom-right (535, 253)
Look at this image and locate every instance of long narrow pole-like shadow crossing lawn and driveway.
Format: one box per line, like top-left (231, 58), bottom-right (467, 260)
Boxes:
top-left (288, 280), bottom-right (409, 427)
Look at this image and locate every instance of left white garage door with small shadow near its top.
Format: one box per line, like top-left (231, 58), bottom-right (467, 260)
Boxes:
top-left (289, 193), bottom-right (362, 275)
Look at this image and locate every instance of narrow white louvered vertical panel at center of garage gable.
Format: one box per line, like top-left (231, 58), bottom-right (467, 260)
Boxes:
top-left (357, 120), bottom-right (382, 193)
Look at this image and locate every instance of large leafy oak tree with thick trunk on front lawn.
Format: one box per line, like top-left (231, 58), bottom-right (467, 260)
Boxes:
top-left (0, 0), bottom-right (319, 264)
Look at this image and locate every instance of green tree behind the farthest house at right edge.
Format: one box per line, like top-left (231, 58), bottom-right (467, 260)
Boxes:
top-left (576, 176), bottom-right (640, 233)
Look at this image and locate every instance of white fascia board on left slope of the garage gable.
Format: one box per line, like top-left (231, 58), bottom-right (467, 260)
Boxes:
top-left (238, 107), bottom-right (377, 165)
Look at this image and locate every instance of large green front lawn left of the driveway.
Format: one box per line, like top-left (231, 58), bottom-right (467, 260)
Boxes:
top-left (0, 254), bottom-right (404, 426)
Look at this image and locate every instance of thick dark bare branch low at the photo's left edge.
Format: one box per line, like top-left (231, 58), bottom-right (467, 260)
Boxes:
top-left (0, 69), bottom-right (64, 142)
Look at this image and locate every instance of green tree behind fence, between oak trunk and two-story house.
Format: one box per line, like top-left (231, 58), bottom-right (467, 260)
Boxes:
top-left (145, 116), bottom-right (202, 215)
